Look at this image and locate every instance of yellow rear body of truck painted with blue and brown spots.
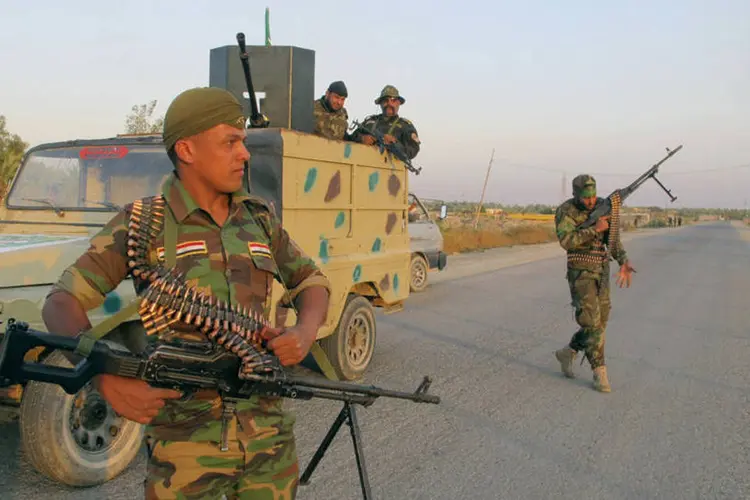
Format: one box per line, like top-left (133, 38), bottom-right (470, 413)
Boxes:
top-left (253, 129), bottom-right (411, 344)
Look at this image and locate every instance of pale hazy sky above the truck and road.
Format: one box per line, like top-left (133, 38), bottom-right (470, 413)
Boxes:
top-left (0, 0), bottom-right (750, 208)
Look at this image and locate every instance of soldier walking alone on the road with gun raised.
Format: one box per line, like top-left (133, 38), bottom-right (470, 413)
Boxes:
top-left (555, 174), bottom-right (634, 392)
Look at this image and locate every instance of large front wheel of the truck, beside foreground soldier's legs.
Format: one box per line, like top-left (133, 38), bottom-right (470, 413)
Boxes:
top-left (19, 351), bottom-right (144, 486)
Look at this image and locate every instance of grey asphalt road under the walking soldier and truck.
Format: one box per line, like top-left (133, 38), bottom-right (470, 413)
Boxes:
top-left (0, 223), bottom-right (750, 500)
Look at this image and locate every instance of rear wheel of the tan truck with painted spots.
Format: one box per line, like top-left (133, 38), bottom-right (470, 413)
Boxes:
top-left (320, 296), bottom-right (376, 380)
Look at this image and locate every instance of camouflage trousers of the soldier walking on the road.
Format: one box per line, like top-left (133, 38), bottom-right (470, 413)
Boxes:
top-left (567, 264), bottom-right (612, 369)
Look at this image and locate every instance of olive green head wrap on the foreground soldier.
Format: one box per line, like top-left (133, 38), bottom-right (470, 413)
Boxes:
top-left (163, 87), bottom-right (245, 151)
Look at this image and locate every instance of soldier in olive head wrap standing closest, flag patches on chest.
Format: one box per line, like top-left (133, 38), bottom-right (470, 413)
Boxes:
top-left (43, 88), bottom-right (330, 500)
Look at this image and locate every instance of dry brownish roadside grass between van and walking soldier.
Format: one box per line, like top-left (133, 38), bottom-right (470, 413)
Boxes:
top-left (442, 224), bottom-right (557, 254)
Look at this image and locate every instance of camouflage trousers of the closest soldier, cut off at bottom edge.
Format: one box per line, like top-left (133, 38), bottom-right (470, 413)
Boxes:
top-left (144, 391), bottom-right (299, 500)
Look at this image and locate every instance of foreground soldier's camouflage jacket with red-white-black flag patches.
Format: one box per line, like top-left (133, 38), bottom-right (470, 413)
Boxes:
top-left (50, 175), bottom-right (330, 441)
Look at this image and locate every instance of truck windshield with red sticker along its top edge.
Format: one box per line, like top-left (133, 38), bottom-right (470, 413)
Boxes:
top-left (7, 144), bottom-right (173, 211)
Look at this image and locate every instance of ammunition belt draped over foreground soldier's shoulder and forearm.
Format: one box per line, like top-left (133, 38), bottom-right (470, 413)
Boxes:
top-left (128, 195), bottom-right (280, 378)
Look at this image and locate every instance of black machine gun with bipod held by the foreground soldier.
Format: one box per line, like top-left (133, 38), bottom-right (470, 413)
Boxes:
top-left (0, 319), bottom-right (440, 499)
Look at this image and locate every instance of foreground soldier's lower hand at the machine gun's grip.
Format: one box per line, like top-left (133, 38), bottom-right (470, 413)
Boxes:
top-left (96, 374), bottom-right (182, 424)
